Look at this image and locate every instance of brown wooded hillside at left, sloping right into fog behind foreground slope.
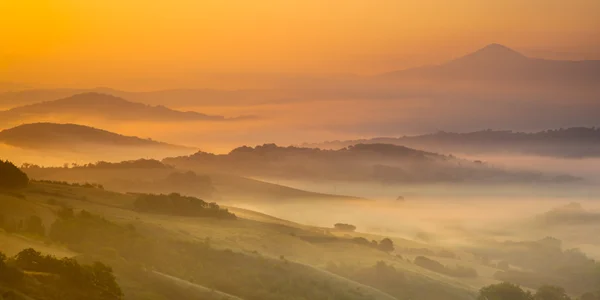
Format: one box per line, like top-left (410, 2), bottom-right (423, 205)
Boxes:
top-left (23, 159), bottom-right (364, 203)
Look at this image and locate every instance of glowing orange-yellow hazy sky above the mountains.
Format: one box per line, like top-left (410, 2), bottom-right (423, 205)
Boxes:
top-left (0, 0), bottom-right (600, 89)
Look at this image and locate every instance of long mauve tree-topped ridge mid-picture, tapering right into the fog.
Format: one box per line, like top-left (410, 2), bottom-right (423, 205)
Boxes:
top-left (163, 144), bottom-right (578, 183)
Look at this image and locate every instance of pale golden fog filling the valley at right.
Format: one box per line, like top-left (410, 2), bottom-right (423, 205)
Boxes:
top-left (231, 157), bottom-right (600, 258)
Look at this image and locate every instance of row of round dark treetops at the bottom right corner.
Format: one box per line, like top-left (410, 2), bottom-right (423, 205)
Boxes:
top-left (477, 282), bottom-right (600, 300)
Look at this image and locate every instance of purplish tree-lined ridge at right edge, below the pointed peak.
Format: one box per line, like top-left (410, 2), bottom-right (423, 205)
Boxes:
top-left (303, 127), bottom-right (600, 158)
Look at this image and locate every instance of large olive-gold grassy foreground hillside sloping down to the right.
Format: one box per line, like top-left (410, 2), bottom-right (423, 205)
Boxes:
top-left (0, 182), bottom-right (475, 300)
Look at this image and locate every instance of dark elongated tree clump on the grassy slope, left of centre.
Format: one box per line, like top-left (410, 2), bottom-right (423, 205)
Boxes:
top-left (134, 193), bottom-right (236, 219)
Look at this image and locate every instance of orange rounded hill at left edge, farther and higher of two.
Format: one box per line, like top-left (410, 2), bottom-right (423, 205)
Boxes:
top-left (0, 93), bottom-right (230, 121)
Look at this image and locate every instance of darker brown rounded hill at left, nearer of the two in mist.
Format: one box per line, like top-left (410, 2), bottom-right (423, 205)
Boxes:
top-left (0, 123), bottom-right (191, 153)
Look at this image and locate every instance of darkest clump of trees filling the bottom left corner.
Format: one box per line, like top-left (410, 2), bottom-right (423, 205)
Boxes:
top-left (0, 249), bottom-right (123, 300)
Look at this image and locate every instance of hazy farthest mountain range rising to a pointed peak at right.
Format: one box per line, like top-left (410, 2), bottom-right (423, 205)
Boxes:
top-left (0, 44), bottom-right (600, 136)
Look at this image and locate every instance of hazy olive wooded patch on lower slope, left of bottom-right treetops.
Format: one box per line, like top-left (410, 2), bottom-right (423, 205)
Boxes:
top-left (327, 261), bottom-right (468, 300)
